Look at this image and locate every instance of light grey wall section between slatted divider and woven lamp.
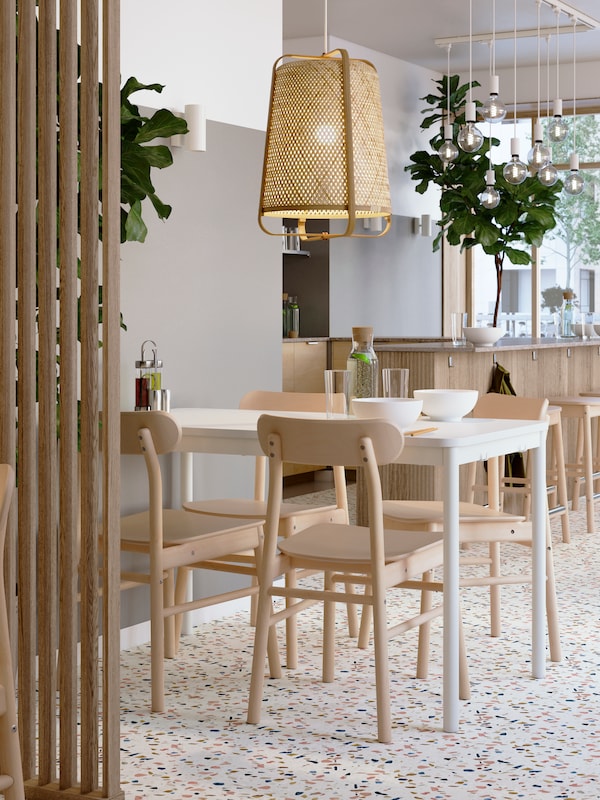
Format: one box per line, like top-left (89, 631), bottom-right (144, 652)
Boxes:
top-left (121, 122), bottom-right (281, 508)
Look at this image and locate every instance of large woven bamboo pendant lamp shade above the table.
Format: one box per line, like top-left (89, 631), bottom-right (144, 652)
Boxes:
top-left (259, 50), bottom-right (391, 239)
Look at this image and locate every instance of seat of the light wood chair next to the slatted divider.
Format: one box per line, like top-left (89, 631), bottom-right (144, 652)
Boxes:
top-left (121, 508), bottom-right (262, 557)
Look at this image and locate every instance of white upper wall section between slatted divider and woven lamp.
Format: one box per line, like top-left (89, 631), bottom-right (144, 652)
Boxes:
top-left (121, 0), bottom-right (282, 130)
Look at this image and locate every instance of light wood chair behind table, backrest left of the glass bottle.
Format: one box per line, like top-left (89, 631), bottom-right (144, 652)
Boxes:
top-left (184, 390), bottom-right (358, 669)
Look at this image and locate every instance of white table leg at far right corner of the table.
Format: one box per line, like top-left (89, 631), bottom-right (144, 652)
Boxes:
top-left (531, 435), bottom-right (548, 678)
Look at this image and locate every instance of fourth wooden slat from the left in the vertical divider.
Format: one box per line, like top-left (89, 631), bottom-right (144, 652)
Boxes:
top-left (58, 0), bottom-right (79, 789)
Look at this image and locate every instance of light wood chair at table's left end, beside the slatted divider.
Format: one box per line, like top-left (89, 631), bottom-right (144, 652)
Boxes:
top-left (121, 411), bottom-right (262, 711)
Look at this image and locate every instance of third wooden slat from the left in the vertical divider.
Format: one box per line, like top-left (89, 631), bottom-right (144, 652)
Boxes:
top-left (37, 0), bottom-right (58, 784)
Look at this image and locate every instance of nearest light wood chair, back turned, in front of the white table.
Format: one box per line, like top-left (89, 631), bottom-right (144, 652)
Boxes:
top-left (248, 415), bottom-right (466, 742)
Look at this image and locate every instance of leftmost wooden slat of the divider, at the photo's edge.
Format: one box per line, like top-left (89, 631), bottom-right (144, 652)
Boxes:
top-left (0, 2), bottom-right (17, 712)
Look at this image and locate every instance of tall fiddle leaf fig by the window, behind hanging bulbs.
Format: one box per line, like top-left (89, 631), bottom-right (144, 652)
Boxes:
top-left (405, 75), bottom-right (562, 326)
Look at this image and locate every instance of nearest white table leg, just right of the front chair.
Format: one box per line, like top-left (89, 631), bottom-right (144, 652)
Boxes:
top-left (443, 448), bottom-right (460, 733)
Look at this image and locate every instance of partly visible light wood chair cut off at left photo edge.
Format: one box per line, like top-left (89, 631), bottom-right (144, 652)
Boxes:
top-left (0, 464), bottom-right (25, 800)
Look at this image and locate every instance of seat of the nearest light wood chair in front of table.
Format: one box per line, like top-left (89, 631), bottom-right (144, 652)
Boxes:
top-left (279, 524), bottom-right (442, 577)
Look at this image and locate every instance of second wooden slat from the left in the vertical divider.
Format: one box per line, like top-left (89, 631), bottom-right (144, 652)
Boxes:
top-left (17, 0), bottom-right (37, 778)
